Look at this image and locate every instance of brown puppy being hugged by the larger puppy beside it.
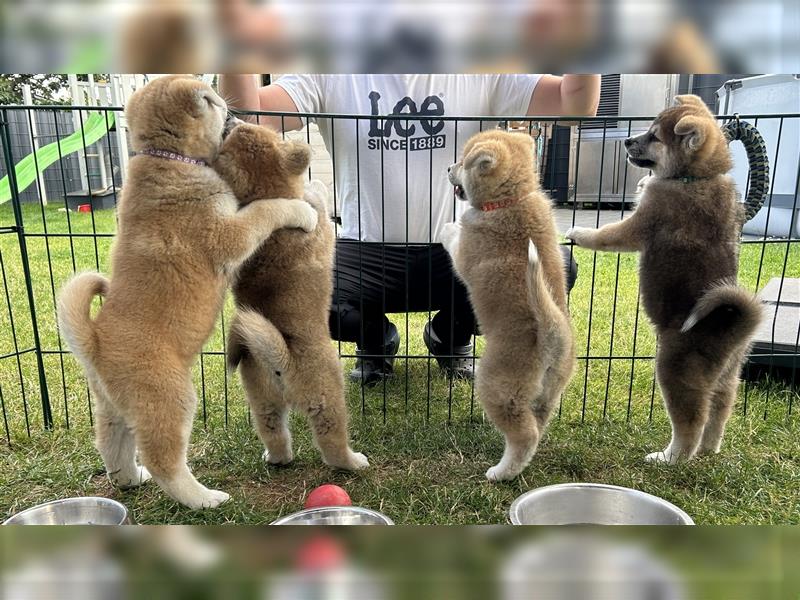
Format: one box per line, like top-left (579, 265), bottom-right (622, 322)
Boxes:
top-left (215, 125), bottom-right (369, 469)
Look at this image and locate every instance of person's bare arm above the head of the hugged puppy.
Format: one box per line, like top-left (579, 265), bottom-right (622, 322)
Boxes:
top-left (219, 75), bottom-right (303, 131)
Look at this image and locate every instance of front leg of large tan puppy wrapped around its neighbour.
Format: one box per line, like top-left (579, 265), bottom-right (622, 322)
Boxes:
top-left (219, 198), bottom-right (319, 266)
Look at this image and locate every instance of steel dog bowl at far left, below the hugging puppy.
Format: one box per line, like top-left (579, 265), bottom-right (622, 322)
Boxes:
top-left (3, 496), bottom-right (131, 525)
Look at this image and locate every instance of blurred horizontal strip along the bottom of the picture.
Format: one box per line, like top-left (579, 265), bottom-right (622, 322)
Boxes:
top-left (0, 526), bottom-right (800, 600)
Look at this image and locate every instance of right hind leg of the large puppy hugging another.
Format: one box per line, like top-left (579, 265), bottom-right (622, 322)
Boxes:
top-left (134, 376), bottom-right (230, 509)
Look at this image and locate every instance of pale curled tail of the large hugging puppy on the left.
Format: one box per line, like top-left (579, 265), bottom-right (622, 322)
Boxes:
top-left (58, 273), bottom-right (108, 364)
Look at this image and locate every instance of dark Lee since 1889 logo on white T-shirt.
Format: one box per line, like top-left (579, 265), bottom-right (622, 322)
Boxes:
top-left (367, 91), bottom-right (447, 150)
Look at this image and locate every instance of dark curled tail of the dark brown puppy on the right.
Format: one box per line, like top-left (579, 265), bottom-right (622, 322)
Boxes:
top-left (681, 281), bottom-right (763, 340)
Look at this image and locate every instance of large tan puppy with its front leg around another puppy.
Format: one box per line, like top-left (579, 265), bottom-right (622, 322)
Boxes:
top-left (58, 76), bottom-right (317, 508)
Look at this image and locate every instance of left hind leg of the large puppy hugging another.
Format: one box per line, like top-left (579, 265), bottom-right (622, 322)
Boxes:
top-left (89, 378), bottom-right (150, 489)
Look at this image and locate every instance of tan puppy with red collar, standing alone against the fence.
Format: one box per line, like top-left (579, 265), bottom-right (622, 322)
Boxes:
top-left (442, 131), bottom-right (575, 480)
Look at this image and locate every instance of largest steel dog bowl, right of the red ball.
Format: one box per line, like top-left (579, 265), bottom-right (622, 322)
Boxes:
top-left (509, 483), bottom-right (694, 525)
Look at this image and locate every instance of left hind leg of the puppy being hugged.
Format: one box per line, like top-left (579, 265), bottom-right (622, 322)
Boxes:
top-left (244, 356), bottom-right (294, 465)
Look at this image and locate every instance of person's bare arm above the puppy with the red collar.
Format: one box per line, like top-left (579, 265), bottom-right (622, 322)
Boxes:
top-left (527, 75), bottom-right (600, 125)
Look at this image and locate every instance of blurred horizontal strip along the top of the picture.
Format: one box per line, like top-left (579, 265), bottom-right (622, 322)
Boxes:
top-left (0, 0), bottom-right (800, 73)
